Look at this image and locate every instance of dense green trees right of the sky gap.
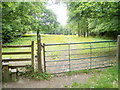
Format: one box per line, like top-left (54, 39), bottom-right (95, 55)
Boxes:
top-left (67, 2), bottom-right (120, 38)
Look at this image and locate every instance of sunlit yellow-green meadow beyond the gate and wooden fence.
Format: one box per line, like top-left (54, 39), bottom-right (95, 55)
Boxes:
top-left (3, 34), bottom-right (114, 59)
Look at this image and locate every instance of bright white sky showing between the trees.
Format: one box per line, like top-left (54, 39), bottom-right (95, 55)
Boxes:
top-left (46, 2), bottom-right (68, 25)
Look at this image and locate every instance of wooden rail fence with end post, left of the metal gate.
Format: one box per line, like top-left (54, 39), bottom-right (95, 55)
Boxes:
top-left (2, 41), bottom-right (34, 68)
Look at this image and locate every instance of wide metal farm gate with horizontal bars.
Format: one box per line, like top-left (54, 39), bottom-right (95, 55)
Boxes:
top-left (43, 40), bottom-right (117, 73)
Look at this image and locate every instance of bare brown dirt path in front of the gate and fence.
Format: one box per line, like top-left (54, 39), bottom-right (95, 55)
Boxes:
top-left (3, 73), bottom-right (93, 88)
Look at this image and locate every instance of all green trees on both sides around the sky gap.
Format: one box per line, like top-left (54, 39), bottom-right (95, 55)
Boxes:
top-left (0, 2), bottom-right (120, 43)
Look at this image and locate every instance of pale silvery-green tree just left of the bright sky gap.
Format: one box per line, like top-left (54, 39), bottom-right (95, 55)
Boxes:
top-left (39, 8), bottom-right (59, 33)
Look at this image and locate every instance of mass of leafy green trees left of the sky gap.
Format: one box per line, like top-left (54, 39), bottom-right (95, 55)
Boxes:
top-left (0, 2), bottom-right (59, 43)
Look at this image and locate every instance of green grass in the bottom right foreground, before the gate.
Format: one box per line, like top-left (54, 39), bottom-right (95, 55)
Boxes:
top-left (65, 66), bottom-right (118, 88)
